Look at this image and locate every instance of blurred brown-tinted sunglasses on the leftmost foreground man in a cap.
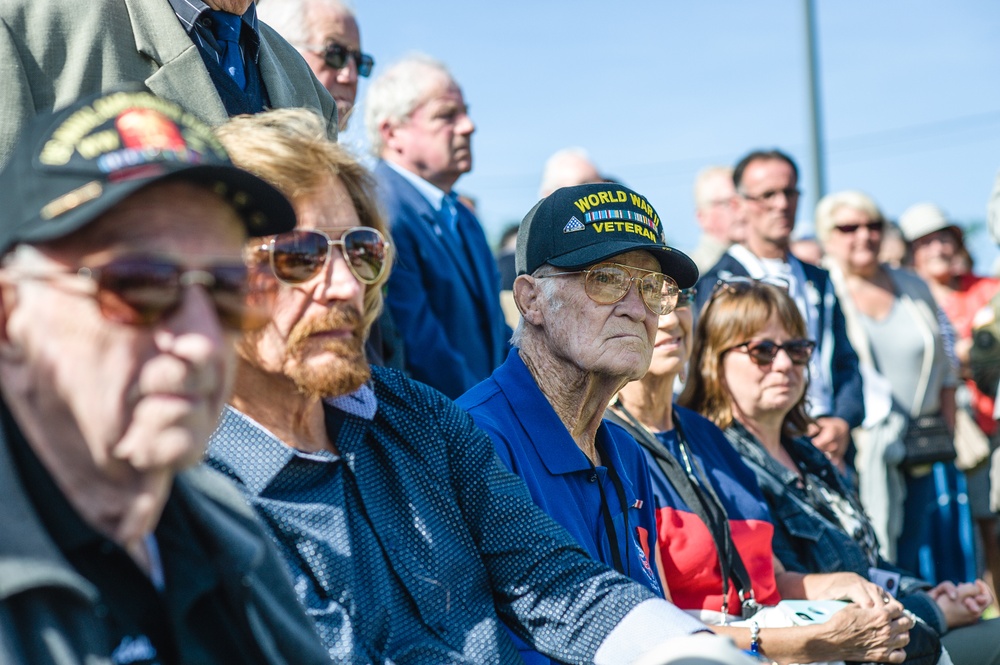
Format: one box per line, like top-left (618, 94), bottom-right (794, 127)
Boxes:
top-left (18, 258), bottom-right (262, 330)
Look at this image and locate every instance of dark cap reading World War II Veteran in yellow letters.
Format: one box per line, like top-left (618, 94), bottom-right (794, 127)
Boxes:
top-left (515, 183), bottom-right (698, 289)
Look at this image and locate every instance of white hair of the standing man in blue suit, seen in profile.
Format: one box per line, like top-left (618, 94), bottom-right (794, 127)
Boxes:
top-left (365, 53), bottom-right (455, 157)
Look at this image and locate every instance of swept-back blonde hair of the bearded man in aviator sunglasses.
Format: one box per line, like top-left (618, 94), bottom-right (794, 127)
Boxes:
top-left (215, 109), bottom-right (393, 330)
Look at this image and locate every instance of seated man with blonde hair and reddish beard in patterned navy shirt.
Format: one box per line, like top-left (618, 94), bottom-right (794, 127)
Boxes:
top-left (209, 110), bottom-right (752, 665)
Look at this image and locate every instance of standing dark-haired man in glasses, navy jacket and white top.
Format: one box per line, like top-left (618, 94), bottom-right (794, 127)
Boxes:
top-left (697, 150), bottom-right (865, 471)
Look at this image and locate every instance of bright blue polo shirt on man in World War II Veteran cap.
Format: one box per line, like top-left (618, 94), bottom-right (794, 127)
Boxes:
top-left (456, 348), bottom-right (663, 665)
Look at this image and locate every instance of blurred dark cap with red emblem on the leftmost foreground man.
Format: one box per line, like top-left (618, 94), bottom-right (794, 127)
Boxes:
top-left (0, 86), bottom-right (295, 252)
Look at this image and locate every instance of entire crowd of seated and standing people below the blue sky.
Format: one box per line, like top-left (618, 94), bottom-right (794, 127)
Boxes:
top-left (0, 0), bottom-right (1000, 665)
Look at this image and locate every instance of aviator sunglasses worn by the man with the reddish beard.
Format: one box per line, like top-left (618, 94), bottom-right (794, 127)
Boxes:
top-left (258, 226), bottom-right (389, 284)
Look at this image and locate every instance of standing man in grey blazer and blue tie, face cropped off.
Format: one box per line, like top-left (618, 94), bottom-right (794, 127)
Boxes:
top-left (0, 0), bottom-right (337, 166)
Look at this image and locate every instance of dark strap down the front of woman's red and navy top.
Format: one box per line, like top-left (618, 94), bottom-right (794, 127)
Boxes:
top-left (608, 400), bottom-right (754, 614)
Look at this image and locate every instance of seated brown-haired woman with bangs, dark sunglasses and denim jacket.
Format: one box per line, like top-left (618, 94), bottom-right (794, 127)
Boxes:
top-left (680, 283), bottom-right (1000, 665)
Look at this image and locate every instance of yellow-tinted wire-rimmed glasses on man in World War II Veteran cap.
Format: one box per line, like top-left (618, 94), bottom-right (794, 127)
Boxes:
top-left (536, 263), bottom-right (679, 315)
